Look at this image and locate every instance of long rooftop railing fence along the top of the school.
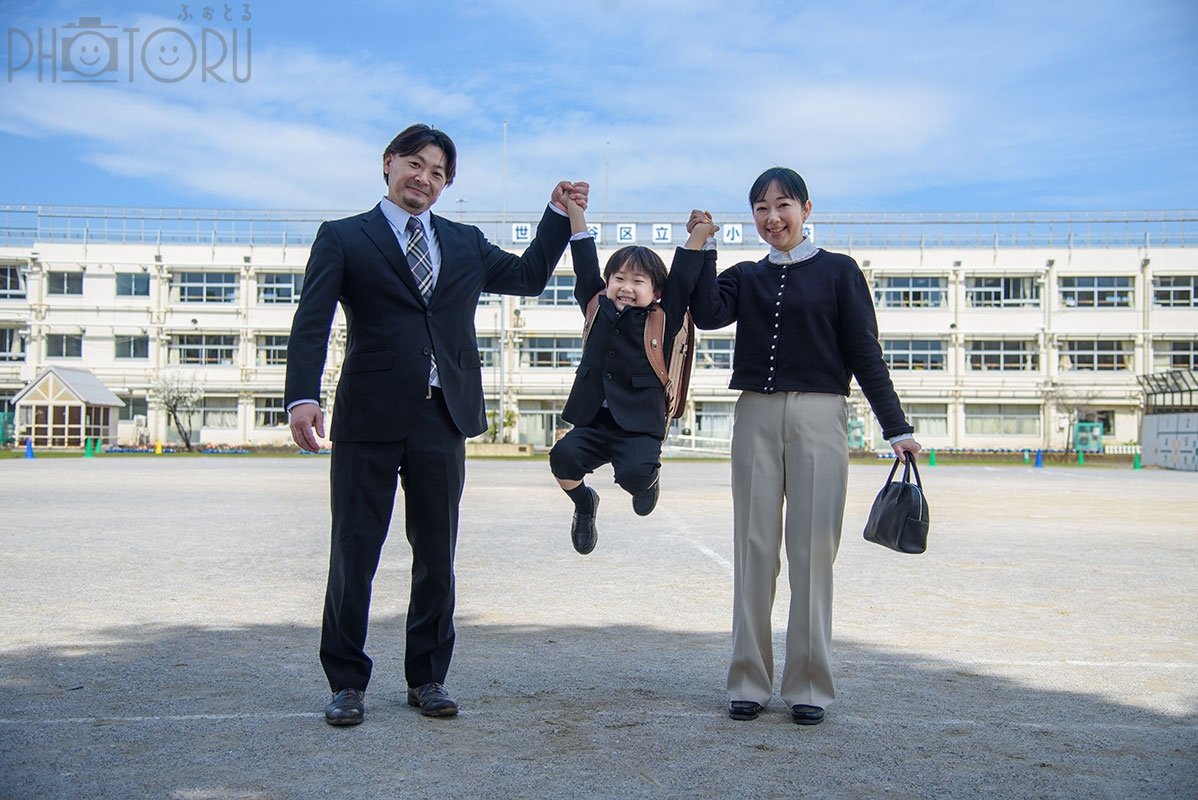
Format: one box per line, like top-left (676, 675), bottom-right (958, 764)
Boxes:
top-left (0, 205), bottom-right (1198, 250)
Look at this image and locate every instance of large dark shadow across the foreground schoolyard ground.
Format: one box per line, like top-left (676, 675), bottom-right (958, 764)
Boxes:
top-left (0, 617), bottom-right (1198, 800)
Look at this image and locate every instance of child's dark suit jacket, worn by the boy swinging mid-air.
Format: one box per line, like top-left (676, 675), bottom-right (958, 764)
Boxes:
top-left (562, 238), bottom-right (715, 438)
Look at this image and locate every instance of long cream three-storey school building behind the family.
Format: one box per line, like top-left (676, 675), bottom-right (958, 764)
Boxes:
top-left (0, 205), bottom-right (1198, 450)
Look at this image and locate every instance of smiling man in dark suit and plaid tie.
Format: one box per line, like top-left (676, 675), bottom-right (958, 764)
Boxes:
top-left (285, 125), bottom-right (587, 725)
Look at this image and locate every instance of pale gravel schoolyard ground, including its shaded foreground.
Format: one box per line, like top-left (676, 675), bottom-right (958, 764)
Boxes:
top-left (0, 456), bottom-right (1198, 800)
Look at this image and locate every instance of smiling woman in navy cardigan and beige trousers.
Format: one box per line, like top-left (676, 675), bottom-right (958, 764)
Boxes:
top-left (691, 166), bottom-right (920, 725)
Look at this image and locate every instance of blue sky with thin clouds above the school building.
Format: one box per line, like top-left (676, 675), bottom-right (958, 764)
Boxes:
top-left (0, 0), bottom-right (1198, 213)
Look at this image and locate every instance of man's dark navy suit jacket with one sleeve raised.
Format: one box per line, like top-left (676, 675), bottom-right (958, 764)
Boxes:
top-left (284, 206), bottom-right (570, 442)
